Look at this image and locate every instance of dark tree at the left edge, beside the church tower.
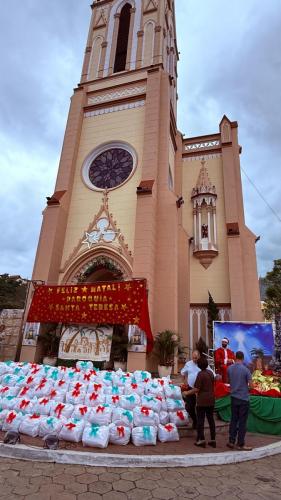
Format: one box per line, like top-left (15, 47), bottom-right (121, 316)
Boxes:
top-left (0, 274), bottom-right (27, 310)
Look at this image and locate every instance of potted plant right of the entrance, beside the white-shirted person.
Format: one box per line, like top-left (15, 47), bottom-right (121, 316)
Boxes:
top-left (153, 330), bottom-right (179, 377)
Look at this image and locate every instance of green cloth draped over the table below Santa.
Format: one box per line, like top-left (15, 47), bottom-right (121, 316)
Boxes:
top-left (215, 396), bottom-right (281, 436)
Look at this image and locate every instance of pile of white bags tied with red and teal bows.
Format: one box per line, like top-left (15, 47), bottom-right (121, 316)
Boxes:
top-left (0, 361), bottom-right (188, 448)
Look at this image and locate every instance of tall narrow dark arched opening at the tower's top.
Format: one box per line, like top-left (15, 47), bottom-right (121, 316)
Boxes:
top-left (114, 3), bottom-right (132, 73)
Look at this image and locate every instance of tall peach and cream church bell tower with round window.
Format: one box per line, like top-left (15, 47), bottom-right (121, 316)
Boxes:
top-left (23, 0), bottom-right (188, 369)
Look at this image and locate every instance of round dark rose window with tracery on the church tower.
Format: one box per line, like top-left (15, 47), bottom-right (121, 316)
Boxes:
top-left (88, 147), bottom-right (134, 189)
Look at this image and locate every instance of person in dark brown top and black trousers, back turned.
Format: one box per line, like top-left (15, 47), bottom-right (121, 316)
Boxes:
top-left (185, 357), bottom-right (216, 448)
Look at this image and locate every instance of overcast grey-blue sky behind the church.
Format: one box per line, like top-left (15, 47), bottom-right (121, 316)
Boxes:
top-left (0, 0), bottom-right (281, 277)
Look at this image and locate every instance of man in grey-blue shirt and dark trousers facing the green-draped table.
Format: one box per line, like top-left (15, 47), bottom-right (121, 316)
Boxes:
top-left (227, 351), bottom-right (252, 451)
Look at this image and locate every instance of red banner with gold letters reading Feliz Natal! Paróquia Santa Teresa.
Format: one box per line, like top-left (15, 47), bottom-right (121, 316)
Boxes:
top-left (27, 280), bottom-right (153, 352)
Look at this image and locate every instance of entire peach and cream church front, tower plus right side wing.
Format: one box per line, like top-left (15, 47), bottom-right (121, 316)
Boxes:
top-left (21, 0), bottom-right (262, 369)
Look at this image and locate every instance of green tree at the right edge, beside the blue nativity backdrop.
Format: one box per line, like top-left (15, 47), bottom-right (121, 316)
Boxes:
top-left (264, 259), bottom-right (281, 371)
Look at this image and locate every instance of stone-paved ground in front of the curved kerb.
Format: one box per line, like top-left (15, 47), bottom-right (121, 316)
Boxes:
top-left (0, 455), bottom-right (281, 500)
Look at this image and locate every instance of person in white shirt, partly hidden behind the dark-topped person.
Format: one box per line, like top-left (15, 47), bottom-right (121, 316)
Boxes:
top-left (181, 350), bottom-right (200, 429)
